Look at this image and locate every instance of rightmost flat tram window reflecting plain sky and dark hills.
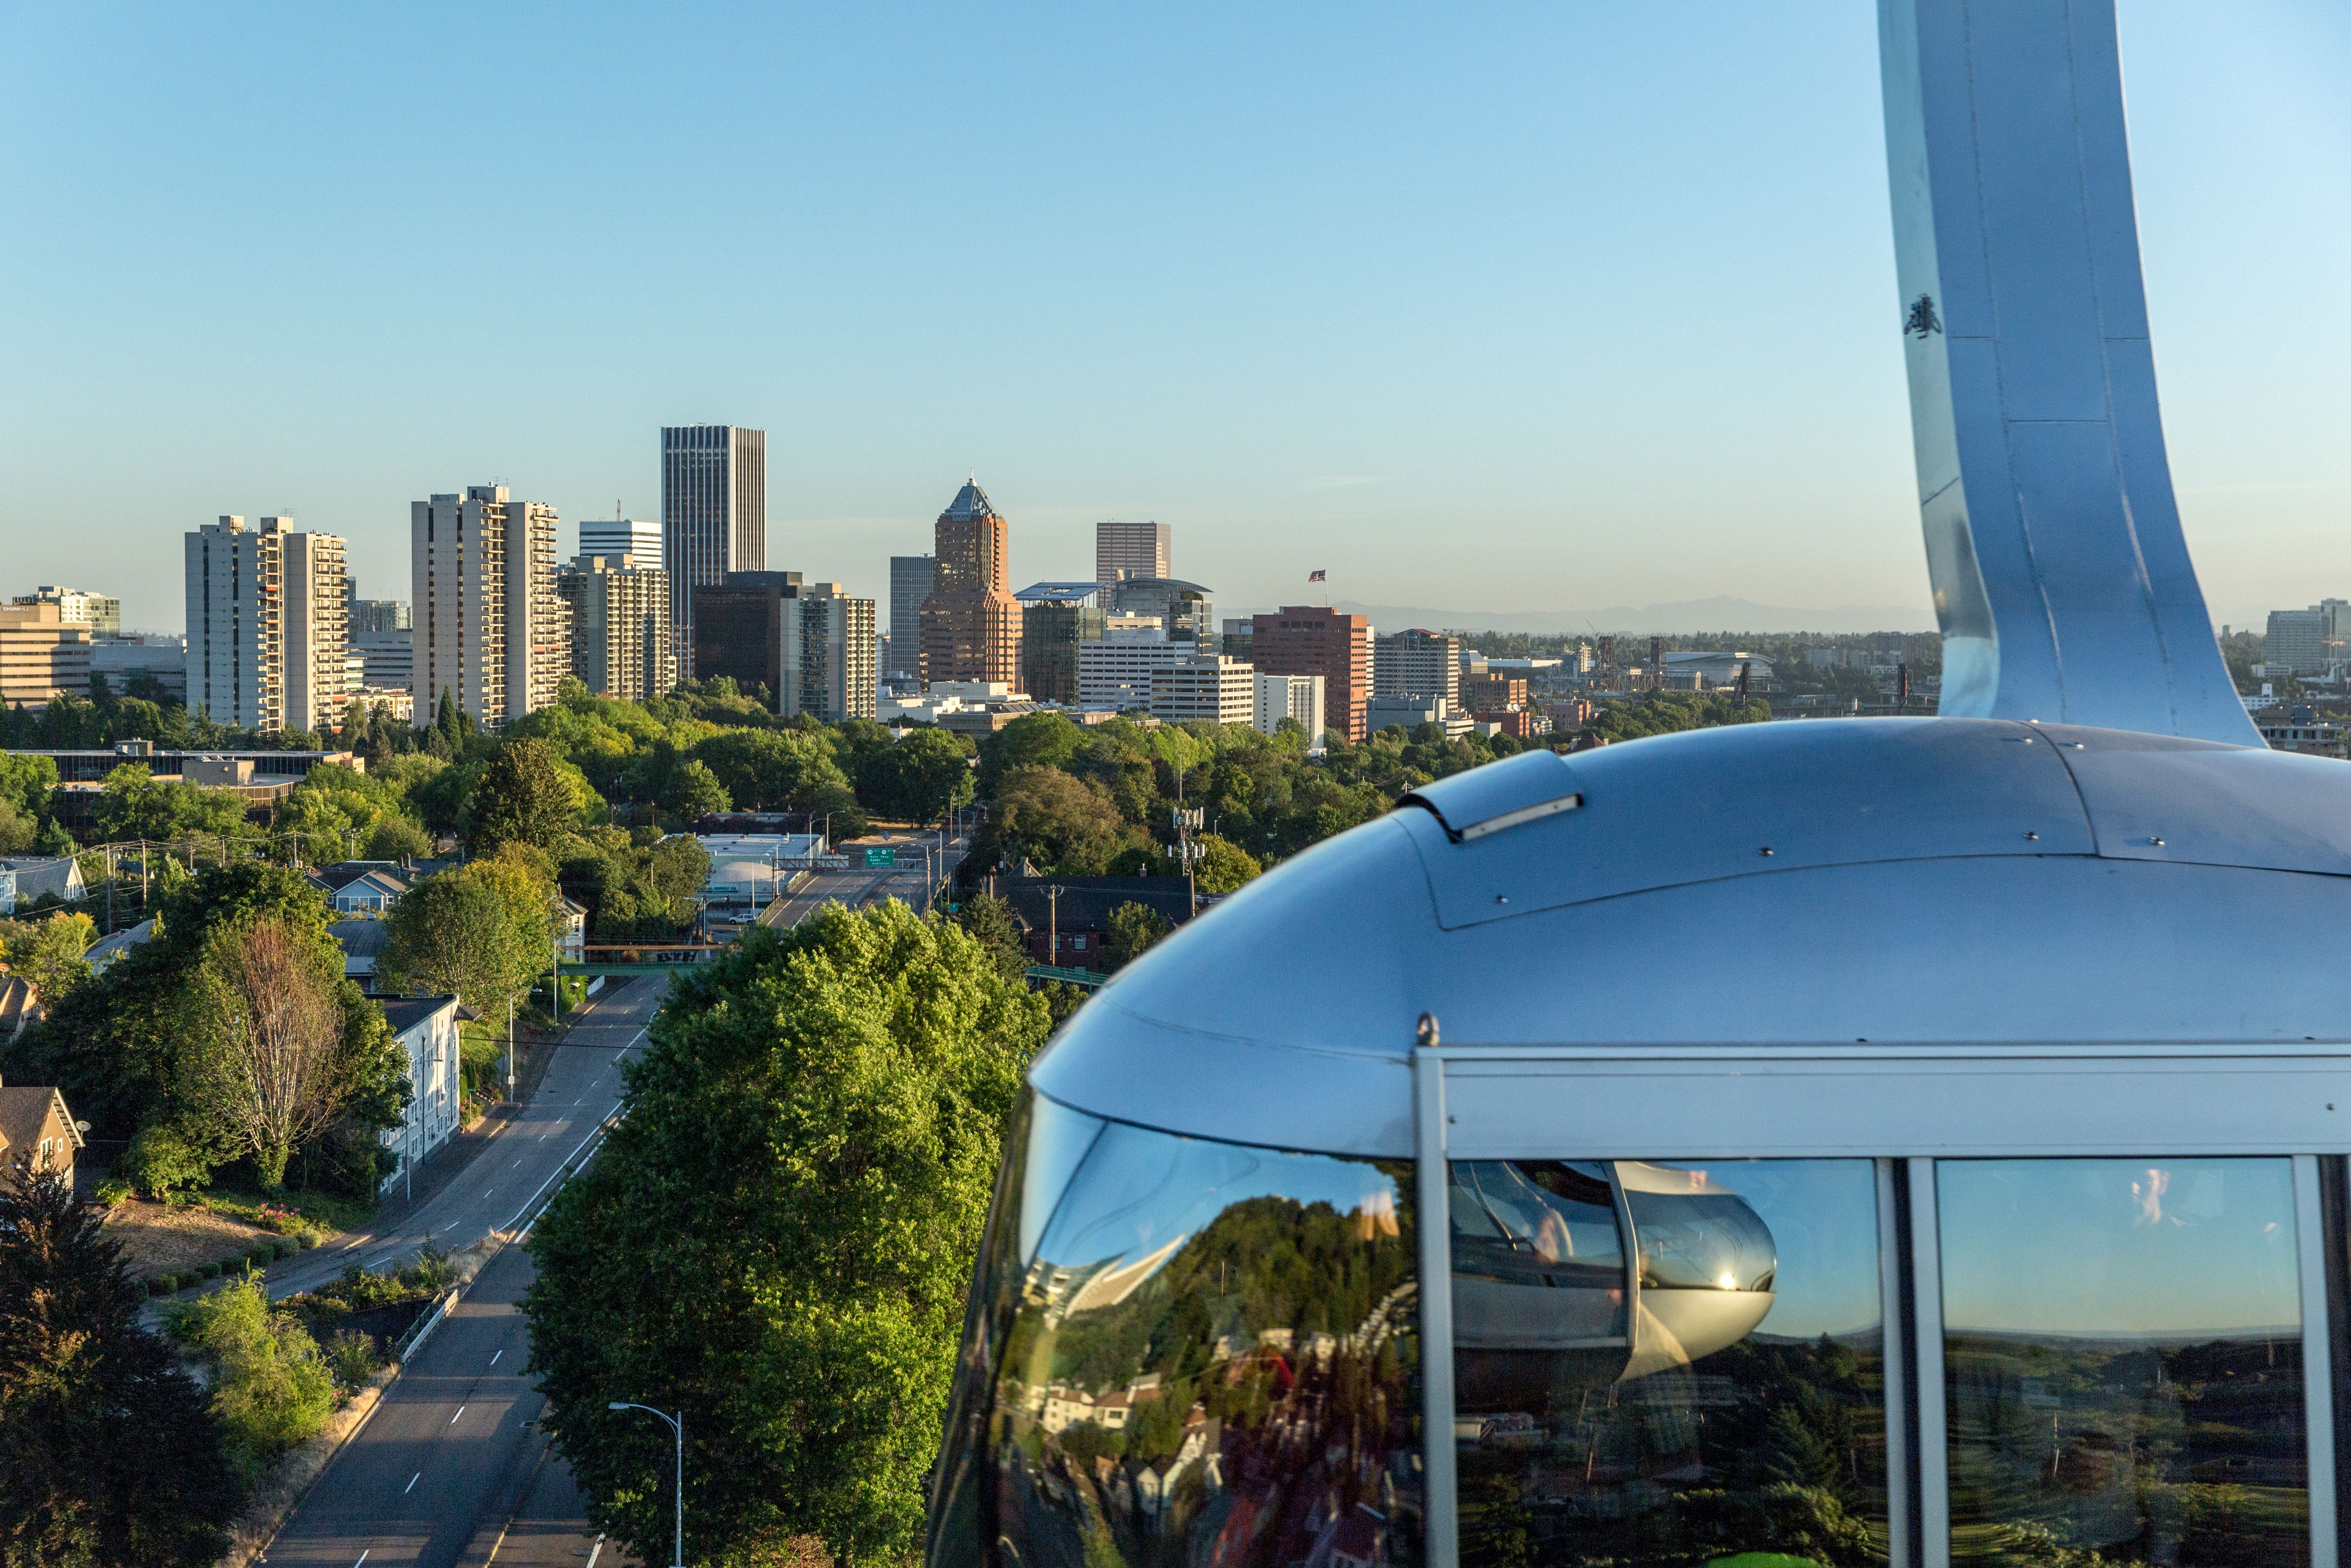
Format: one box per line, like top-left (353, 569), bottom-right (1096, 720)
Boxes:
top-left (1935, 1159), bottom-right (2309, 1568)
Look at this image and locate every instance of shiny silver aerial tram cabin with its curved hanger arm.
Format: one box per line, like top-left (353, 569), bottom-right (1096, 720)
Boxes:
top-left (929, 0), bottom-right (2351, 1568)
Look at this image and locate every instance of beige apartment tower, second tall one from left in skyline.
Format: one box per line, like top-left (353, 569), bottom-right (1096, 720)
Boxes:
top-left (409, 484), bottom-right (571, 729)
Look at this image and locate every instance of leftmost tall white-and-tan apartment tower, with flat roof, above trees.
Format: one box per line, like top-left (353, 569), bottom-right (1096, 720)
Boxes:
top-left (186, 515), bottom-right (351, 731)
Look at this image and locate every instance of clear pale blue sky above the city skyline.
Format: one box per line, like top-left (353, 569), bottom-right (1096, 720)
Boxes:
top-left (0, 0), bottom-right (2351, 628)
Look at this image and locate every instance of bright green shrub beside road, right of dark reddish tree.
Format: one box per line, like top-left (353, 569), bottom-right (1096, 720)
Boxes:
top-left (165, 1279), bottom-right (334, 1479)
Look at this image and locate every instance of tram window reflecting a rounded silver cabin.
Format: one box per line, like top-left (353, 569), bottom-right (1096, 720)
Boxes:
top-left (1450, 1159), bottom-right (1888, 1568)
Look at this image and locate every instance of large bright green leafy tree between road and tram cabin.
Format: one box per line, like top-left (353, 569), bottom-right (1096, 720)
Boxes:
top-left (524, 903), bottom-right (1049, 1563)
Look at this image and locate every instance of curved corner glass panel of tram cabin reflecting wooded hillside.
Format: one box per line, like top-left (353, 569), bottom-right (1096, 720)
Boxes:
top-left (931, 1100), bottom-right (1420, 1568)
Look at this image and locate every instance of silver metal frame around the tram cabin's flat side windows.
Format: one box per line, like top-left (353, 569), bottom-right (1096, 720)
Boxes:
top-left (1413, 1042), bottom-right (2351, 1568)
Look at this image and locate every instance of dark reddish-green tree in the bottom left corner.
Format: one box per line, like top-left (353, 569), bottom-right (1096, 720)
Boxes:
top-left (0, 1175), bottom-right (245, 1568)
